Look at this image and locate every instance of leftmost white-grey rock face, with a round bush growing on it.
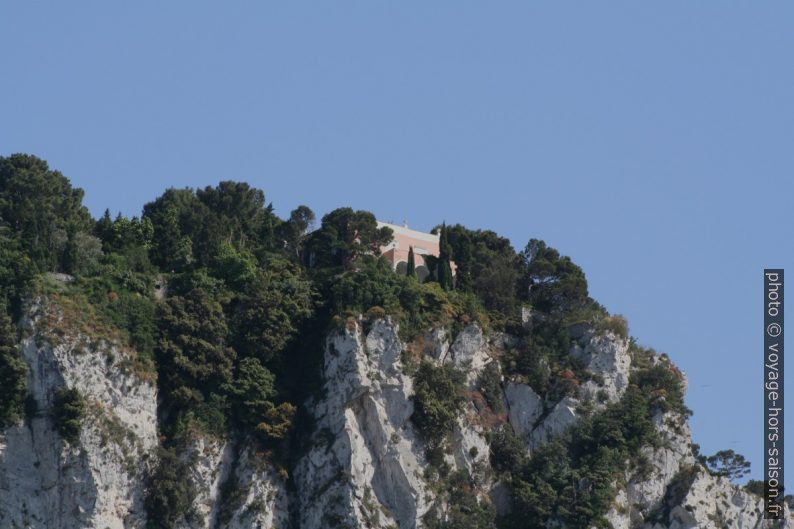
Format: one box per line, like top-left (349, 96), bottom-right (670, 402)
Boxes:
top-left (0, 300), bottom-right (157, 529)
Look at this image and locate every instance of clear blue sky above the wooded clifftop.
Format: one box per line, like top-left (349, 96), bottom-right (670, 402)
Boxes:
top-left (0, 0), bottom-right (794, 488)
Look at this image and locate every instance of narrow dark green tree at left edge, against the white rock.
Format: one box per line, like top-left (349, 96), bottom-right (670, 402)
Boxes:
top-left (0, 303), bottom-right (28, 430)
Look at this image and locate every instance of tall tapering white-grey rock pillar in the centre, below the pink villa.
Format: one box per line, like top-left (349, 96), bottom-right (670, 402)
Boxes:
top-left (295, 319), bottom-right (430, 529)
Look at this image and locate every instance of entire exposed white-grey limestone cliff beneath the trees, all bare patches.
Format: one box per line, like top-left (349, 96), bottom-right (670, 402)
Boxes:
top-left (0, 299), bottom-right (794, 529)
